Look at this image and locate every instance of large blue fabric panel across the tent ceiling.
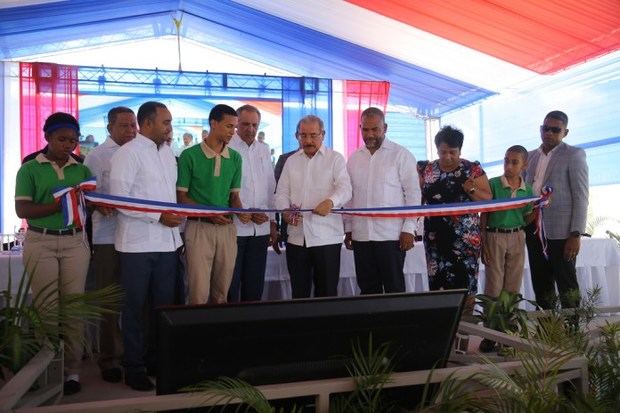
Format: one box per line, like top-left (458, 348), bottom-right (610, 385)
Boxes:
top-left (0, 0), bottom-right (494, 116)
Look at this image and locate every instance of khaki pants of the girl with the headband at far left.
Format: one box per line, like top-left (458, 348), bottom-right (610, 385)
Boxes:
top-left (24, 231), bottom-right (90, 375)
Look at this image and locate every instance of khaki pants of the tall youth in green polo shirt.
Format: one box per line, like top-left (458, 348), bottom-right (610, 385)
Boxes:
top-left (185, 220), bottom-right (237, 304)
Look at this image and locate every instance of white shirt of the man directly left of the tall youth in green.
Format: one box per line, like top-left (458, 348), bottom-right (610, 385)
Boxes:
top-left (110, 134), bottom-right (182, 252)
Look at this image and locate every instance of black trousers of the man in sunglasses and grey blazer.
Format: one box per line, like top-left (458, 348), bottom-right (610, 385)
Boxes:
top-left (525, 224), bottom-right (579, 309)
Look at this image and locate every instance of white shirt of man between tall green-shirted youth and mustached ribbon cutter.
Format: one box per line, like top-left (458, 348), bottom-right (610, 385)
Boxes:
top-left (228, 134), bottom-right (276, 237)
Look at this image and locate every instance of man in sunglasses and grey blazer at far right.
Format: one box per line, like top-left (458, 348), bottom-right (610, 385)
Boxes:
top-left (525, 110), bottom-right (588, 309)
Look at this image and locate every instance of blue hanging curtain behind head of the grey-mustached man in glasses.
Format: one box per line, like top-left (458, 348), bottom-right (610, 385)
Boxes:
top-left (282, 77), bottom-right (333, 153)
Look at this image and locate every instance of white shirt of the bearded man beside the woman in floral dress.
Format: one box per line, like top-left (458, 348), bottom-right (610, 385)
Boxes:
top-left (344, 139), bottom-right (420, 241)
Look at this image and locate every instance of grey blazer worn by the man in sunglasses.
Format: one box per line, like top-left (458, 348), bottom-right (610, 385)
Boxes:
top-left (525, 142), bottom-right (588, 239)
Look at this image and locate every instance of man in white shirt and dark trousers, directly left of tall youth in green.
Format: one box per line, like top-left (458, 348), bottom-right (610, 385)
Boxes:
top-left (110, 102), bottom-right (183, 391)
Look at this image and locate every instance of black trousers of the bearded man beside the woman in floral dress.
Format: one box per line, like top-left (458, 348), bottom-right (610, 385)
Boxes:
top-left (353, 241), bottom-right (406, 294)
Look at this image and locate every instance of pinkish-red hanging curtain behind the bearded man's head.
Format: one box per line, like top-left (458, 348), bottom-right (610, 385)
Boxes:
top-left (344, 80), bottom-right (390, 157)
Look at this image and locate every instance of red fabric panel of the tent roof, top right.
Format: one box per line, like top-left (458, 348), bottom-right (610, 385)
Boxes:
top-left (347, 0), bottom-right (620, 74)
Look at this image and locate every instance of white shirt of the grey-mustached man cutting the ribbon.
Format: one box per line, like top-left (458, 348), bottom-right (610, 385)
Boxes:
top-left (276, 145), bottom-right (351, 247)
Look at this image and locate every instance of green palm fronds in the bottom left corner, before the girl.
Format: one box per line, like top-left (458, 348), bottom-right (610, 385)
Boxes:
top-left (0, 262), bottom-right (122, 379)
